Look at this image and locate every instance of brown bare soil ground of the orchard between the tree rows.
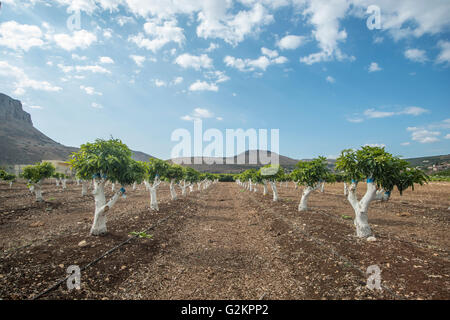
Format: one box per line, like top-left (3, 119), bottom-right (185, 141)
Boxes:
top-left (0, 183), bottom-right (450, 299)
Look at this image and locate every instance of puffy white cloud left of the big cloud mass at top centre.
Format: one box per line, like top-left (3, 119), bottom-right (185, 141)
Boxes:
top-left (128, 20), bottom-right (186, 53)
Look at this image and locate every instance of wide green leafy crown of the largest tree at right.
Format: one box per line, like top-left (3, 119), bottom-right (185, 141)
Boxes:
top-left (336, 146), bottom-right (429, 194)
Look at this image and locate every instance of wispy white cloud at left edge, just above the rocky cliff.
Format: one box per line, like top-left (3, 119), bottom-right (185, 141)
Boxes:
top-left (0, 61), bottom-right (62, 95)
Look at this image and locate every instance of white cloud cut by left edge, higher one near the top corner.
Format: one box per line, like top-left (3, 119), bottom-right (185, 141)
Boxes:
top-left (0, 21), bottom-right (44, 51)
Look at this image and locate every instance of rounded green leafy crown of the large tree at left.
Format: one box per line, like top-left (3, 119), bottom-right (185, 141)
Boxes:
top-left (69, 138), bottom-right (137, 185)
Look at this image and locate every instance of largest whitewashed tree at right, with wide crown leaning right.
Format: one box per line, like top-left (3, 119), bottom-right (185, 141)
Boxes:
top-left (336, 146), bottom-right (429, 238)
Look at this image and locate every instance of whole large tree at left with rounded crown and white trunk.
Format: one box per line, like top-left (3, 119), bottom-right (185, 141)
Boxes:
top-left (69, 138), bottom-right (144, 235)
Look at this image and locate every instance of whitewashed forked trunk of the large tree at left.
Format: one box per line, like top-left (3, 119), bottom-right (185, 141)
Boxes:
top-left (91, 180), bottom-right (122, 236)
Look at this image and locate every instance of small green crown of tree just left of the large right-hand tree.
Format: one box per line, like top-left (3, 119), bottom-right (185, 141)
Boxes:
top-left (291, 157), bottom-right (331, 188)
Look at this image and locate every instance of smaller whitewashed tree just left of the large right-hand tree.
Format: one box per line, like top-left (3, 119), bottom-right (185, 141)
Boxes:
top-left (291, 157), bottom-right (330, 211)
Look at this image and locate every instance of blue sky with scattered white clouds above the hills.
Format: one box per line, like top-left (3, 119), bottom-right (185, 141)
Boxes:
top-left (0, 0), bottom-right (450, 159)
